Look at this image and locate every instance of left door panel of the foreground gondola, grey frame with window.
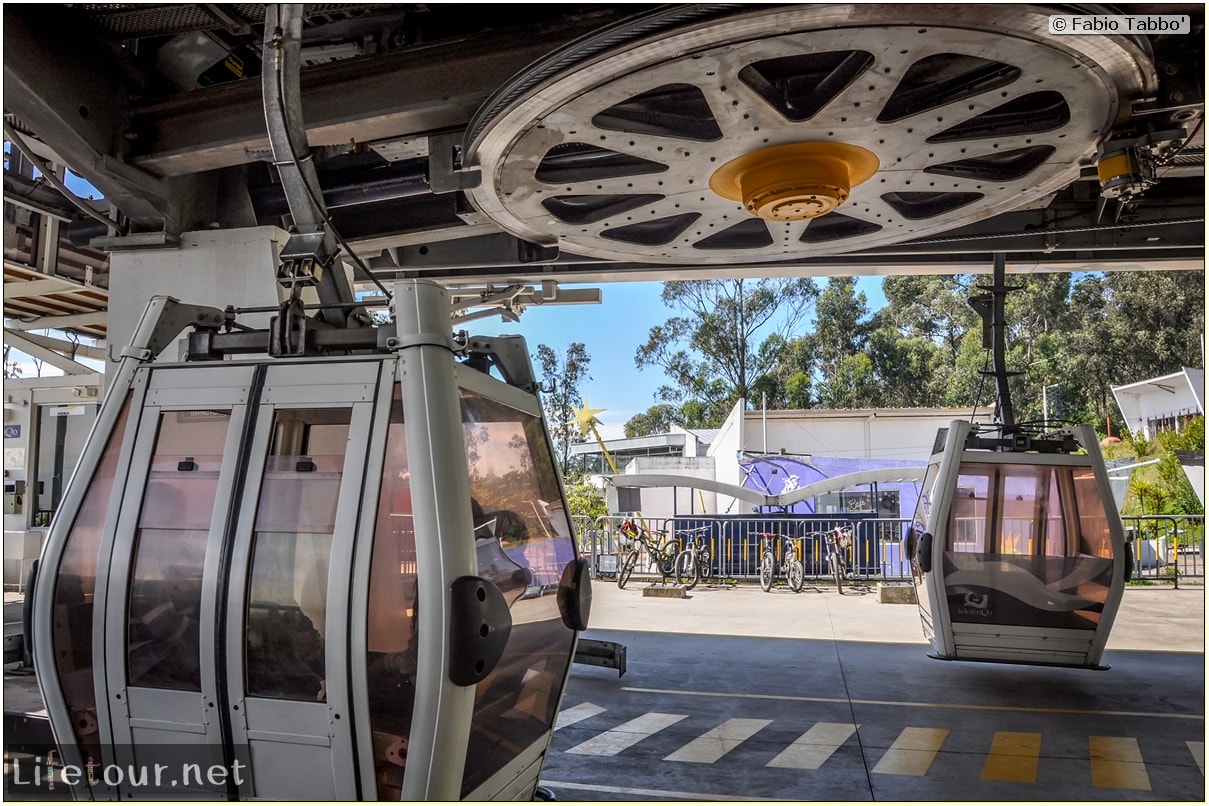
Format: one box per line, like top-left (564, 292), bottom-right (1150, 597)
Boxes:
top-left (98, 366), bottom-right (254, 798)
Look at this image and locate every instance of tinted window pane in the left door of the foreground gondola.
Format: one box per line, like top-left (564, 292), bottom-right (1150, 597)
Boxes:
top-left (126, 411), bottom-right (231, 691)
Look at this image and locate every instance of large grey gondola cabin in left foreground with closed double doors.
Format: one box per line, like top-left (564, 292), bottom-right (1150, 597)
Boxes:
top-left (31, 280), bottom-right (590, 800)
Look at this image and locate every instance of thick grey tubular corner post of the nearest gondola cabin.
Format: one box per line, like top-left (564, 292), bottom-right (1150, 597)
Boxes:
top-left (394, 280), bottom-right (478, 801)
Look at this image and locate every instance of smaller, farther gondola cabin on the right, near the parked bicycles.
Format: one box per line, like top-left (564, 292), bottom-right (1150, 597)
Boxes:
top-left (908, 422), bottom-right (1128, 668)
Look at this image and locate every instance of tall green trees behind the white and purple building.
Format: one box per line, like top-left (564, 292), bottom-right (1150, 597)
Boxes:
top-left (635, 273), bottom-right (1205, 459)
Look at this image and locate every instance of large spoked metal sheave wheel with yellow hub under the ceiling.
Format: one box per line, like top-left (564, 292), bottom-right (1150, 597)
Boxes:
top-left (463, 4), bottom-right (1153, 265)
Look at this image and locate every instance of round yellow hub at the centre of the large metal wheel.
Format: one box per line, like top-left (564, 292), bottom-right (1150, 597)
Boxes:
top-left (710, 143), bottom-right (881, 221)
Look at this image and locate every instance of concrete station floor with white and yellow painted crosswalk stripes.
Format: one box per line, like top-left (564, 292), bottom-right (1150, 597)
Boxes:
top-left (543, 582), bottom-right (1205, 802)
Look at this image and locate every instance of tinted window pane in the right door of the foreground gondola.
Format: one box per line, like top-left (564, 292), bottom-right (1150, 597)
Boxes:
top-left (247, 408), bottom-right (351, 702)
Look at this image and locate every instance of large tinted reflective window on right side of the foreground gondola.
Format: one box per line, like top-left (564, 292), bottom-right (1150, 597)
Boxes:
top-left (462, 393), bottom-right (575, 796)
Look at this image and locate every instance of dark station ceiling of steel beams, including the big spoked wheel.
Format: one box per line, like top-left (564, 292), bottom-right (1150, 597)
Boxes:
top-left (4, 4), bottom-right (1204, 315)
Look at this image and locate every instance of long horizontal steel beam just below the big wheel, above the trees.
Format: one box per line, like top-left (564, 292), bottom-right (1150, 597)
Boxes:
top-left (354, 180), bottom-right (1205, 283)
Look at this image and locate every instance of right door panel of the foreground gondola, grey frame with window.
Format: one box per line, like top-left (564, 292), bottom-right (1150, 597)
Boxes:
top-left (224, 361), bottom-right (382, 800)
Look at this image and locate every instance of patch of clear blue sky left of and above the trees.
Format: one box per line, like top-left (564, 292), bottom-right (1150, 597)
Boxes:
top-left (465, 277), bottom-right (885, 439)
